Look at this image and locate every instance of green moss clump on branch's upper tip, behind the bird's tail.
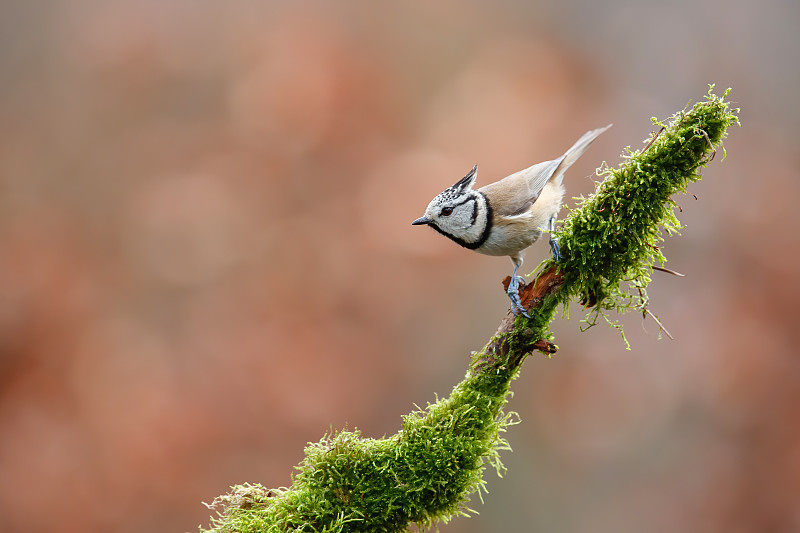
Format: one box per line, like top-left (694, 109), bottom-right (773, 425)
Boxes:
top-left (556, 86), bottom-right (738, 336)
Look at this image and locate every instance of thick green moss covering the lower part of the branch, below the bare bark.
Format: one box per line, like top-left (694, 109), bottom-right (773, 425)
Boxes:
top-left (206, 373), bottom-right (513, 532)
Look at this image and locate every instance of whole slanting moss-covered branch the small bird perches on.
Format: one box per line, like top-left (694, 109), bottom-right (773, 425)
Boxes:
top-left (200, 87), bottom-right (738, 533)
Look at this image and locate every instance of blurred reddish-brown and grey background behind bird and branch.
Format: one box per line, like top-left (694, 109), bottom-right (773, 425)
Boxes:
top-left (0, 0), bottom-right (800, 533)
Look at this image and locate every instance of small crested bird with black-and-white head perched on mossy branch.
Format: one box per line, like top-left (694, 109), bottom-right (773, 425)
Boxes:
top-left (411, 124), bottom-right (612, 318)
